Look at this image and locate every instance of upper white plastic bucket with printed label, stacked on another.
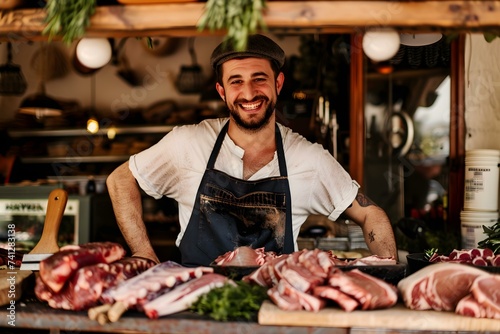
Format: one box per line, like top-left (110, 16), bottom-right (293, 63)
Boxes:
top-left (464, 149), bottom-right (500, 211)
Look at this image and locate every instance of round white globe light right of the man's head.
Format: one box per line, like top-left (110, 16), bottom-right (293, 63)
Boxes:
top-left (363, 28), bottom-right (400, 62)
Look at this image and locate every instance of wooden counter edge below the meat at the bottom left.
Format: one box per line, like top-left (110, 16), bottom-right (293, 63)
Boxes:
top-left (0, 299), bottom-right (342, 334)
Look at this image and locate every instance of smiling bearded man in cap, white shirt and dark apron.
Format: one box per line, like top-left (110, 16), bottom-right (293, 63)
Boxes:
top-left (107, 35), bottom-right (397, 266)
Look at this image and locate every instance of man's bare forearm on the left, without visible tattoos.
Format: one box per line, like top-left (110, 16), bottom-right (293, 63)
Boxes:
top-left (106, 162), bottom-right (160, 263)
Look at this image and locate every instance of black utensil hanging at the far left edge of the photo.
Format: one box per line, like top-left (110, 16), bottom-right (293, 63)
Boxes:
top-left (0, 42), bottom-right (27, 95)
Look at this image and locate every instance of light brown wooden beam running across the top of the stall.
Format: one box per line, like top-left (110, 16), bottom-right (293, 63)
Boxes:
top-left (0, 0), bottom-right (500, 40)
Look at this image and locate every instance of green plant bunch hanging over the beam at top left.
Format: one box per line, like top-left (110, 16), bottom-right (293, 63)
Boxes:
top-left (43, 0), bottom-right (97, 44)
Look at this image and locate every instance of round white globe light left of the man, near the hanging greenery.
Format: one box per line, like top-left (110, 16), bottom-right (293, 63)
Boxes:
top-left (76, 38), bottom-right (112, 69)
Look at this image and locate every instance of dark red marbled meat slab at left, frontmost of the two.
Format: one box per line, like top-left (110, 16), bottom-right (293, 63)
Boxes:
top-left (35, 257), bottom-right (155, 311)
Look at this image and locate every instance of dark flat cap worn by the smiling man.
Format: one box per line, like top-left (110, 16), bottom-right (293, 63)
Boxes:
top-left (210, 35), bottom-right (285, 70)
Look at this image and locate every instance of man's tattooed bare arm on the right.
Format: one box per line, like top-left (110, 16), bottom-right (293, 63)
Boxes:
top-left (344, 192), bottom-right (398, 260)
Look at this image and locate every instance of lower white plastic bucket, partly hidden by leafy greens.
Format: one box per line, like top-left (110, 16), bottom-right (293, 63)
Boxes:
top-left (460, 211), bottom-right (499, 249)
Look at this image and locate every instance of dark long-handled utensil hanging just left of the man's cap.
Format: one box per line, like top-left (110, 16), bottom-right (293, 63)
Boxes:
top-left (175, 37), bottom-right (205, 94)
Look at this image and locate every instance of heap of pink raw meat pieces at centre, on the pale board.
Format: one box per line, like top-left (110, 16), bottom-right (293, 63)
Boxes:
top-left (243, 249), bottom-right (398, 312)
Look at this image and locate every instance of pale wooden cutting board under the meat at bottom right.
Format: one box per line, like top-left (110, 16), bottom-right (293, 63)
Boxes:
top-left (259, 301), bottom-right (500, 331)
